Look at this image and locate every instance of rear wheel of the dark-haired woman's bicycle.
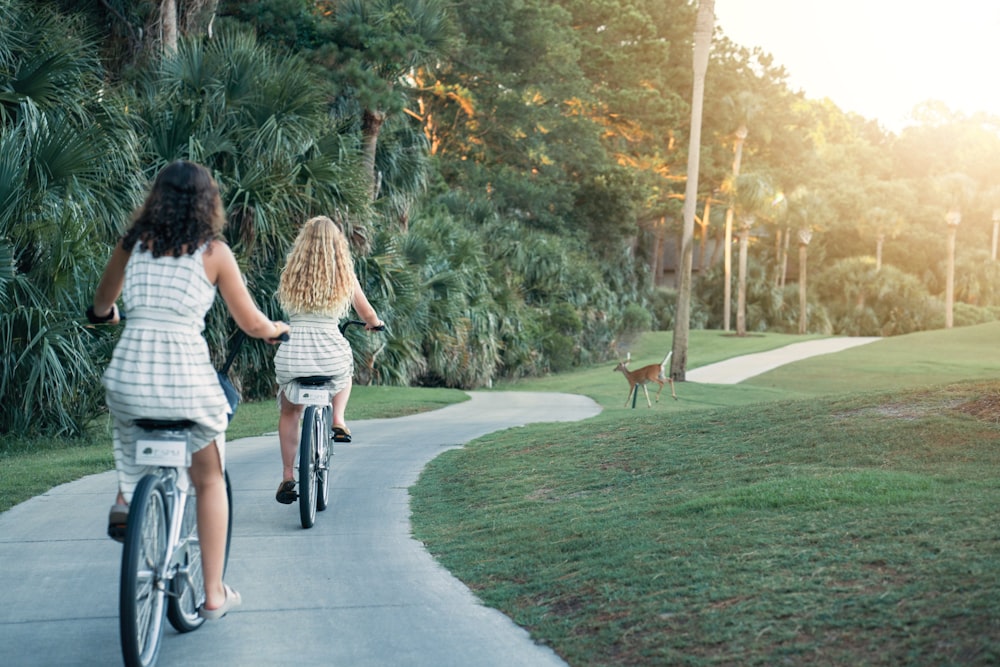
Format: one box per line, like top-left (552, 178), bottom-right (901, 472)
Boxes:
top-left (118, 475), bottom-right (168, 667)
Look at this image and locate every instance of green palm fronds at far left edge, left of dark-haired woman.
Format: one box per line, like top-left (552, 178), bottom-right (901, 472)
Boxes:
top-left (0, 0), bottom-right (140, 434)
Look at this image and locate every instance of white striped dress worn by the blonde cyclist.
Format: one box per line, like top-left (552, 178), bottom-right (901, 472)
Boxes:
top-left (274, 314), bottom-right (354, 402)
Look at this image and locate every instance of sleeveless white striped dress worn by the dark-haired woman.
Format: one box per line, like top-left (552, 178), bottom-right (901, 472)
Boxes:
top-left (103, 245), bottom-right (229, 501)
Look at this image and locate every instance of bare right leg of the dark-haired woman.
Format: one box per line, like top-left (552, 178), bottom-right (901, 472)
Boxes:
top-left (190, 442), bottom-right (229, 609)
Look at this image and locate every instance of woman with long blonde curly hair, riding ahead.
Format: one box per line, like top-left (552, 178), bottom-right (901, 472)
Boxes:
top-left (274, 215), bottom-right (382, 505)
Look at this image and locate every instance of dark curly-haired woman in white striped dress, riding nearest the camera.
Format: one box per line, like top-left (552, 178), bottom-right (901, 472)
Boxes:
top-left (87, 160), bottom-right (288, 618)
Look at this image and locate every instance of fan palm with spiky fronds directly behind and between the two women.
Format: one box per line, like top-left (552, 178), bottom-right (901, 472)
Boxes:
top-left (130, 30), bottom-right (371, 396)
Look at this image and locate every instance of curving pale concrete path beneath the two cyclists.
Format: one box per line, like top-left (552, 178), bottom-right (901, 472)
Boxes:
top-left (0, 392), bottom-right (601, 667)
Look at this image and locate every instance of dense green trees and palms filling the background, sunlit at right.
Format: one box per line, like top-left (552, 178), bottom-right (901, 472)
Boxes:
top-left (0, 0), bottom-right (1000, 433)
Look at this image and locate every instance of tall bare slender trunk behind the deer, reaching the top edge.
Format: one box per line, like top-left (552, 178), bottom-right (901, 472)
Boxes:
top-left (670, 0), bottom-right (715, 381)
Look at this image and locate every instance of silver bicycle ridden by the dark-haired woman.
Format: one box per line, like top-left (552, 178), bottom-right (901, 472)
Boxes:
top-left (118, 332), bottom-right (272, 667)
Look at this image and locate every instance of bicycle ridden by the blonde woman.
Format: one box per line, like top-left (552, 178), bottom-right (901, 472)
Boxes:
top-left (288, 320), bottom-right (385, 529)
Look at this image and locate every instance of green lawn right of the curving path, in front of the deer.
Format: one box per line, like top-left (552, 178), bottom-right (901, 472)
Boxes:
top-left (412, 324), bottom-right (1000, 667)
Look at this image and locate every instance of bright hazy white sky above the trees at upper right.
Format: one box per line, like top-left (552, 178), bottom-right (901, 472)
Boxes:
top-left (715, 0), bottom-right (1000, 132)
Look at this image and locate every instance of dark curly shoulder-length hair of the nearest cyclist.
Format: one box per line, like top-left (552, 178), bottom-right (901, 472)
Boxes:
top-left (122, 160), bottom-right (226, 257)
